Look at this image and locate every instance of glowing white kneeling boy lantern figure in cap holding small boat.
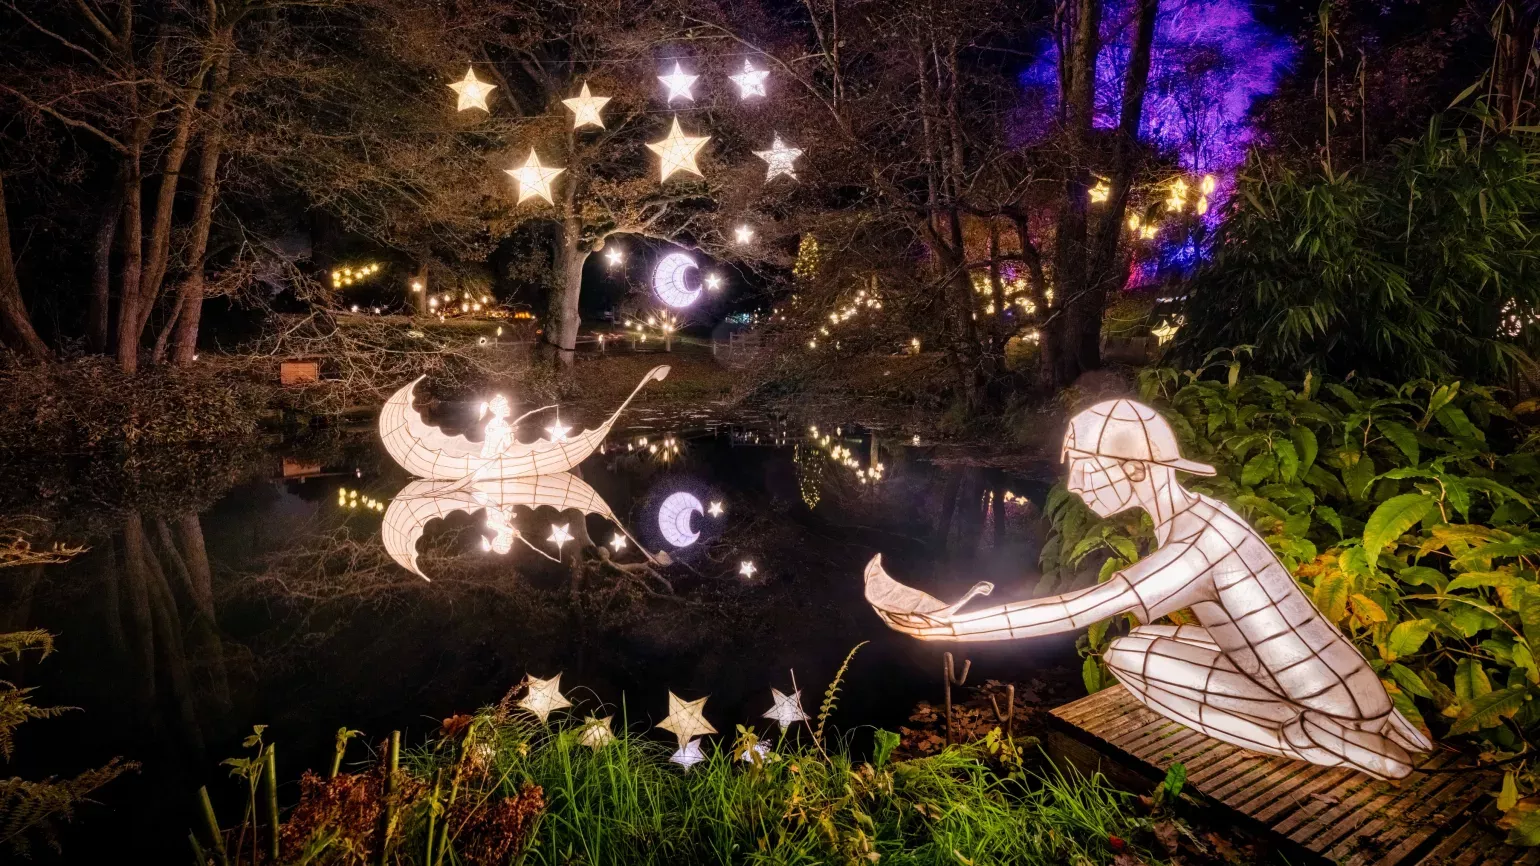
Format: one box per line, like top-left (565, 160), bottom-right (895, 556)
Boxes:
top-left (865, 401), bottom-right (1432, 778)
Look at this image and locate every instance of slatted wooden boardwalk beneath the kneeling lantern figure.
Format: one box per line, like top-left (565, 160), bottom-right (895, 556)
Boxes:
top-left (1053, 686), bottom-right (1540, 866)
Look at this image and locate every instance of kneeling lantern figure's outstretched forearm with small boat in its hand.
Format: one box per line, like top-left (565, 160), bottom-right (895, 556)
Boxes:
top-left (865, 559), bottom-right (1147, 641)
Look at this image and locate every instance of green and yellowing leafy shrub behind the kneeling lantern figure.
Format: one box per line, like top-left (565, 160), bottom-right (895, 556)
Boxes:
top-left (1041, 356), bottom-right (1540, 838)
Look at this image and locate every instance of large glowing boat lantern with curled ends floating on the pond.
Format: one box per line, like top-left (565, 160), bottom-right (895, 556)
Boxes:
top-left (379, 365), bottom-right (668, 481)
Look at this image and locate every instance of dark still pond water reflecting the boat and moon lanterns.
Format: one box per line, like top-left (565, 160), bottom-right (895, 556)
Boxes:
top-left (0, 400), bottom-right (1075, 861)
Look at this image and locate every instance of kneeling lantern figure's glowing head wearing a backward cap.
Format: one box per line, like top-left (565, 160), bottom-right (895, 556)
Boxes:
top-left (1061, 399), bottom-right (1214, 518)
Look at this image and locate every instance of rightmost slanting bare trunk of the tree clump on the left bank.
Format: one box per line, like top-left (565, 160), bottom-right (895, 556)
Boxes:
top-left (166, 35), bottom-right (234, 367)
